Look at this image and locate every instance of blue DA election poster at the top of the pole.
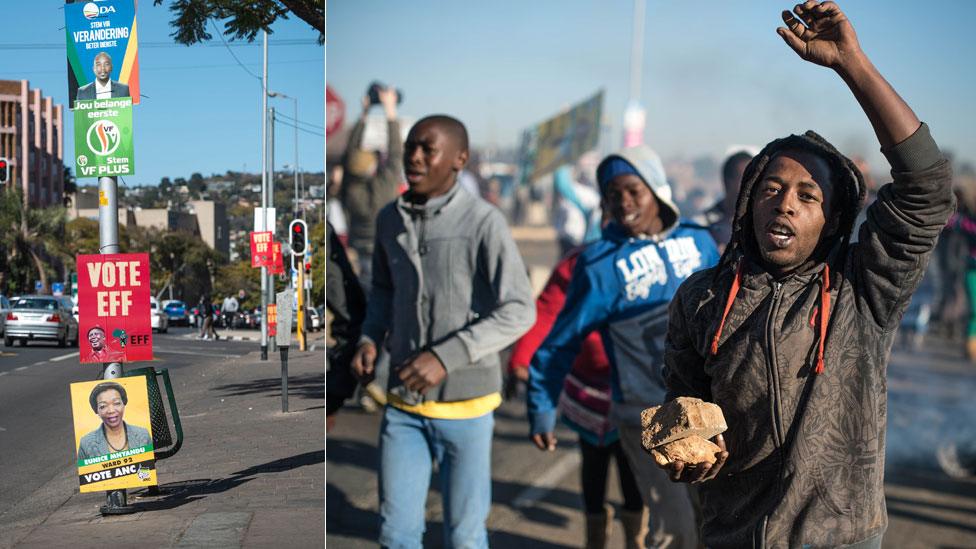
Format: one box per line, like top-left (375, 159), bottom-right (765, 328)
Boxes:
top-left (64, 0), bottom-right (139, 109)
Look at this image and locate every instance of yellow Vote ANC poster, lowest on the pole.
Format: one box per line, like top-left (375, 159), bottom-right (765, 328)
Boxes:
top-left (71, 376), bottom-right (157, 492)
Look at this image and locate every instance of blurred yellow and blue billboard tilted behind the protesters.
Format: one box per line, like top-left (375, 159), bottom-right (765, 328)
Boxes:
top-left (519, 90), bottom-right (603, 182)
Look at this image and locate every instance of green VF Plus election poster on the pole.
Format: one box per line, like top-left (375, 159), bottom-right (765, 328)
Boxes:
top-left (75, 97), bottom-right (136, 177)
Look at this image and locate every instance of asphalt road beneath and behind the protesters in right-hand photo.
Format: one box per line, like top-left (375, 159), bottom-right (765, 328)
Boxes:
top-left (326, 230), bottom-right (976, 549)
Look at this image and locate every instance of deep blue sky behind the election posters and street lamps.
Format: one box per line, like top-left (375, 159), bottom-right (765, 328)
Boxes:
top-left (0, 0), bottom-right (325, 186)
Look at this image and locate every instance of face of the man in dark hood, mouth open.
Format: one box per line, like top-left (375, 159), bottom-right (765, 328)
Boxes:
top-left (751, 151), bottom-right (838, 275)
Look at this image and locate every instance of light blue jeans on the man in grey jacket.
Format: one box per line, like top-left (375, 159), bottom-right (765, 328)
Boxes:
top-left (379, 406), bottom-right (495, 549)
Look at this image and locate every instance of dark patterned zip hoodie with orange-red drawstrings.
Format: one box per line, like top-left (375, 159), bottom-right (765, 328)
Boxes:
top-left (664, 124), bottom-right (954, 548)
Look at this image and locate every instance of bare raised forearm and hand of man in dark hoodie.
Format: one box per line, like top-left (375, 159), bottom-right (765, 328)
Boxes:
top-left (776, 0), bottom-right (921, 149)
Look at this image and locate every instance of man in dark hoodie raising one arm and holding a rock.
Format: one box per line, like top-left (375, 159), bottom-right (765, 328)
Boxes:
top-left (664, 0), bottom-right (954, 548)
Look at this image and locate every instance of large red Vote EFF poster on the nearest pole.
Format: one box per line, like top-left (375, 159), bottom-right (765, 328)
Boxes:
top-left (77, 253), bottom-right (152, 363)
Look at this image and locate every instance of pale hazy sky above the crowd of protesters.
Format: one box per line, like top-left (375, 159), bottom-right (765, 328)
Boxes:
top-left (326, 0), bottom-right (976, 172)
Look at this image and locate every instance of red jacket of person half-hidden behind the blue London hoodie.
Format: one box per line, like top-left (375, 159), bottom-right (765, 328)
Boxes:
top-left (508, 247), bottom-right (610, 387)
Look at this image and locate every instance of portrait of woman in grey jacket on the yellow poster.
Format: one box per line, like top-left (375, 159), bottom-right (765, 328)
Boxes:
top-left (78, 381), bottom-right (152, 459)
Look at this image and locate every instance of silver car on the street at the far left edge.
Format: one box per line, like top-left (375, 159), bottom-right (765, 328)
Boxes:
top-left (3, 295), bottom-right (78, 347)
